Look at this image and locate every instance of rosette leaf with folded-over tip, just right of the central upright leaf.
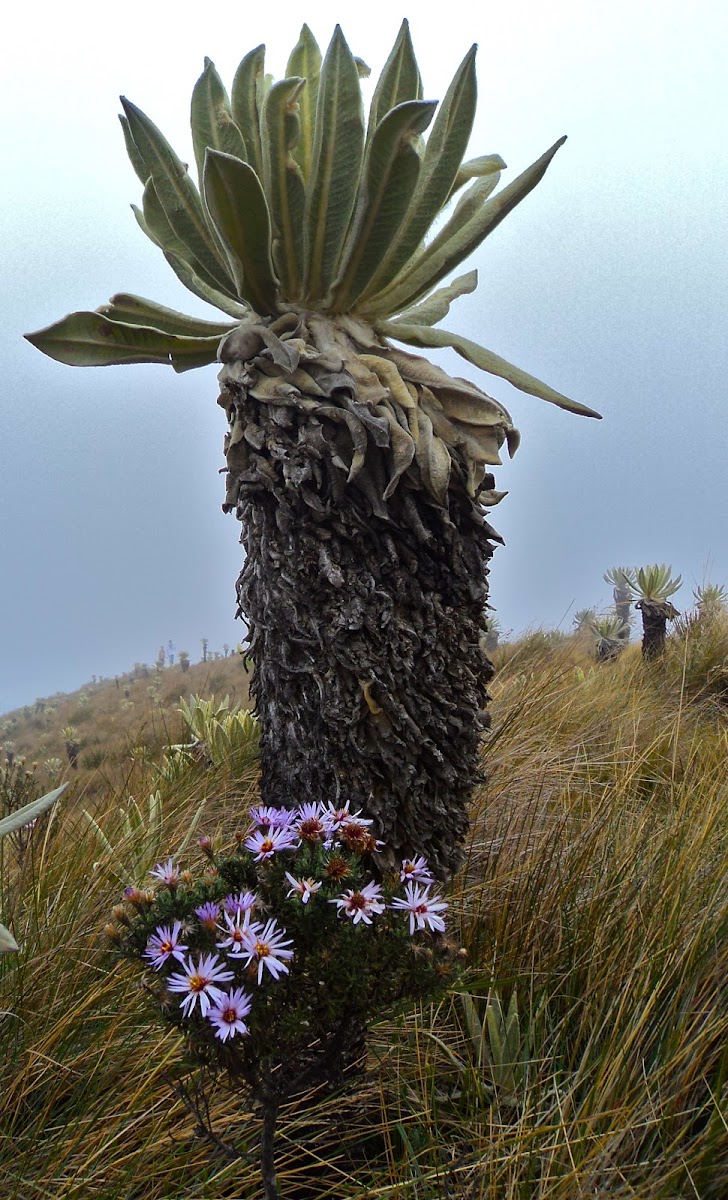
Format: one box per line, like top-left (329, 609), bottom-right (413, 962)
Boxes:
top-left (333, 100), bottom-right (437, 311)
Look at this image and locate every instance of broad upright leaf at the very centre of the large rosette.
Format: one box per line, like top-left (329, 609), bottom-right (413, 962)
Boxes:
top-left (305, 25), bottom-right (363, 300)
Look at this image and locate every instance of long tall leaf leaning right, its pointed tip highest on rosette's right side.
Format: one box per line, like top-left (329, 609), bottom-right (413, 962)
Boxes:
top-left (366, 46), bottom-right (482, 304)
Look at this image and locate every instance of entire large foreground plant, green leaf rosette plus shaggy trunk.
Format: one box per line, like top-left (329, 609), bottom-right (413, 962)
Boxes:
top-left (28, 22), bottom-right (598, 874)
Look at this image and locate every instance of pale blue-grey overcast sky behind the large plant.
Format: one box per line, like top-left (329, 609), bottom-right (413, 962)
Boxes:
top-left (0, 0), bottom-right (728, 712)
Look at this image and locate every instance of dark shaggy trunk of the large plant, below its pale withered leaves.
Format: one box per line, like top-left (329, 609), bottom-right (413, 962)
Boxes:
top-left (215, 321), bottom-right (500, 876)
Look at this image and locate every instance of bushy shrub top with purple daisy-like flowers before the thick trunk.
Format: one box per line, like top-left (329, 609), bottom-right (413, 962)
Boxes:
top-left (109, 804), bottom-right (455, 1060)
